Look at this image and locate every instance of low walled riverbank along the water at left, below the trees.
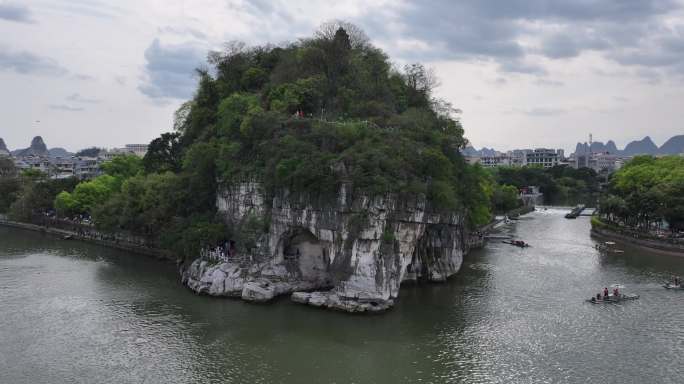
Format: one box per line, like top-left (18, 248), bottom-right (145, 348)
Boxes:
top-left (0, 217), bottom-right (176, 263)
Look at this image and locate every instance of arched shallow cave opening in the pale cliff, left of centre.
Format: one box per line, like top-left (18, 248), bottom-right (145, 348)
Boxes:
top-left (282, 228), bottom-right (330, 280)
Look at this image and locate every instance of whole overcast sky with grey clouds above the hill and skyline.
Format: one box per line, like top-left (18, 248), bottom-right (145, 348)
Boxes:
top-left (0, 0), bottom-right (684, 150)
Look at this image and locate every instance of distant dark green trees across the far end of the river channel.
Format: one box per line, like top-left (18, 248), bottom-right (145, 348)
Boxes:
top-left (493, 166), bottom-right (599, 205)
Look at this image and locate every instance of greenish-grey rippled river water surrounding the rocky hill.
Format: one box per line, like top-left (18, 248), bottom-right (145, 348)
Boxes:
top-left (0, 209), bottom-right (684, 384)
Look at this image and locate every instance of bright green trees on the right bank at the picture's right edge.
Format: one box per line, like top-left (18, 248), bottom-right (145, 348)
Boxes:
top-left (600, 156), bottom-right (684, 232)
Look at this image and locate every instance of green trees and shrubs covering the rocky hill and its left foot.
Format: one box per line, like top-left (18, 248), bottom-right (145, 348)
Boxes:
top-left (5, 23), bottom-right (496, 255)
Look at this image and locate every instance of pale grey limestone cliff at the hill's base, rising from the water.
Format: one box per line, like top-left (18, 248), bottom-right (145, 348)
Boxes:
top-left (181, 183), bottom-right (467, 312)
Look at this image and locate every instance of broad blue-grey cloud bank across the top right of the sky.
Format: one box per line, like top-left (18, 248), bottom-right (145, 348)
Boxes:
top-left (361, 0), bottom-right (682, 76)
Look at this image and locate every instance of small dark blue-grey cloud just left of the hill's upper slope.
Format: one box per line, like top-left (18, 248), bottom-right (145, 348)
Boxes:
top-left (138, 39), bottom-right (206, 99)
